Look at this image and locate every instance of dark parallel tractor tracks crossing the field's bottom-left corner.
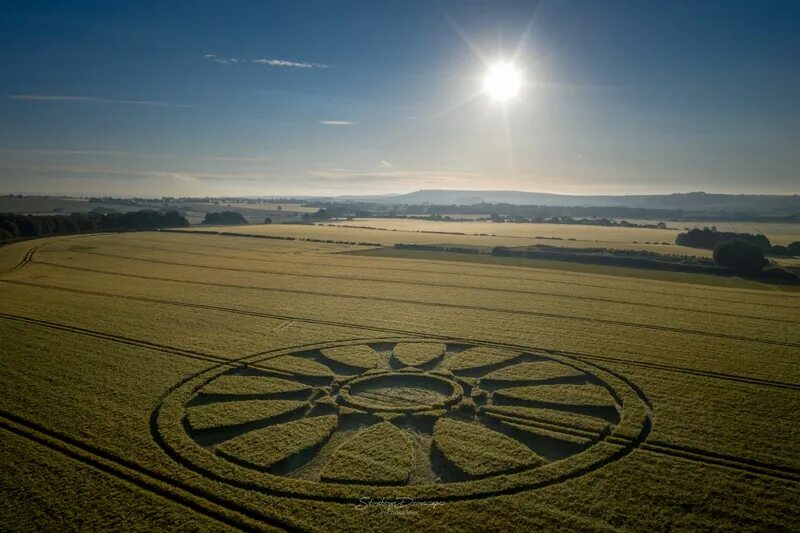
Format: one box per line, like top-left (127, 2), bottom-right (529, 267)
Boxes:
top-left (0, 410), bottom-right (302, 531)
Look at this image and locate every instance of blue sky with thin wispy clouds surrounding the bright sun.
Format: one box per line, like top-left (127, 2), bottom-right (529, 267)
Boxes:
top-left (0, 0), bottom-right (800, 197)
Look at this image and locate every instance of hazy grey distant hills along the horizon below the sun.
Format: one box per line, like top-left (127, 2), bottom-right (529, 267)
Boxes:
top-left (333, 189), bottom-right (800, 211)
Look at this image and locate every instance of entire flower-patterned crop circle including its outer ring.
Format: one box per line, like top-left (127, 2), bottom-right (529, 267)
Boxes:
top-left (153, 337), bottom-right (651, 502)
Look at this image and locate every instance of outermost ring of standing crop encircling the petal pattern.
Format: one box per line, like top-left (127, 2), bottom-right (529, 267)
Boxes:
top-left (151, 336), bottom-right (652, 503)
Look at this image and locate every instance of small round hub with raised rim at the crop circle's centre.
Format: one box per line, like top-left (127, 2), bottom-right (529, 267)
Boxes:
top-left (339, 372), bottom-right (463, 412)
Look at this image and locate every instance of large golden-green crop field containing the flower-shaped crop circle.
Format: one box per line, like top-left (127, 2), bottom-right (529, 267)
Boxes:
top-left (0, 231), bottom-right (800, 531)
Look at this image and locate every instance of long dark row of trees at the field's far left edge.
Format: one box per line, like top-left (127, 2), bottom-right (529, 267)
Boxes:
top-left (0, 210), bottom-right (189, 241)
